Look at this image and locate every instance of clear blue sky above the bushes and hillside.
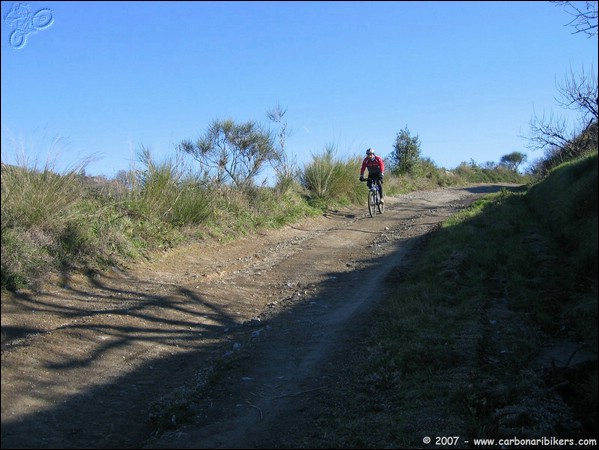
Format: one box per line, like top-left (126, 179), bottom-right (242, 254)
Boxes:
top-left (1, 1), bottom-right (597, 178)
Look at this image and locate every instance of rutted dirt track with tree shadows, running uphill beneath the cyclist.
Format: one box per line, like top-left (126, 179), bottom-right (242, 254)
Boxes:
top-left (1, 185), bottom-right (516, 448)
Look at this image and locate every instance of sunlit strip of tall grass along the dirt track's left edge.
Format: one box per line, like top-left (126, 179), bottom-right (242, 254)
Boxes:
top-left (1, 156), bottom-right (527, 290)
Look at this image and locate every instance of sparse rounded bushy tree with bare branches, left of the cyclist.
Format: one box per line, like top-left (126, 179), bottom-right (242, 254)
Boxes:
top-left (179, 120), bottom-right (278, 187)
